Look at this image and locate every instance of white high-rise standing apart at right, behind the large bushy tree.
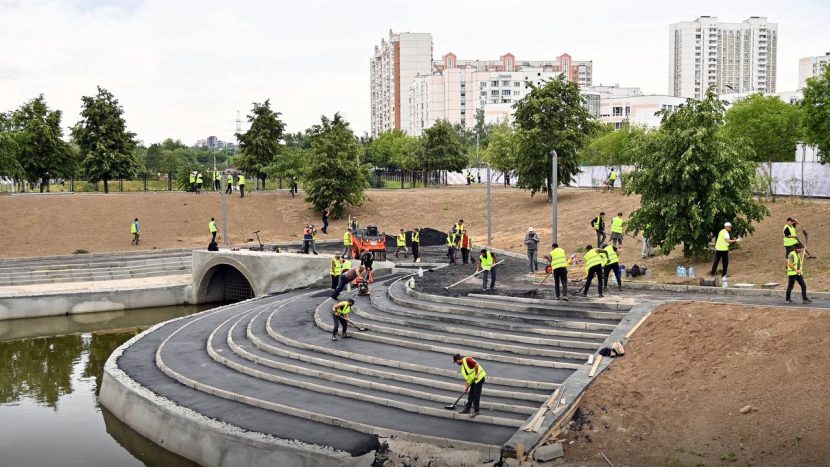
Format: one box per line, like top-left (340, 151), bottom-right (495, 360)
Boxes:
top-left (669, 16), bottom-right (778, 99)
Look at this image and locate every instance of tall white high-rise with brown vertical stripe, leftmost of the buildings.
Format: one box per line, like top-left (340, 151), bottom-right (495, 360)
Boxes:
top-left (369, 31), bottom-right (432, 136)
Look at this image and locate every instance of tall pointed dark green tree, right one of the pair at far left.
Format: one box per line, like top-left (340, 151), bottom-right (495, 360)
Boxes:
top-left (72, 86), bottom-right (139, 193)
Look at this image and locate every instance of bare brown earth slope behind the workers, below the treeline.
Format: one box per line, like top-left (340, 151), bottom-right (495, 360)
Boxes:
top-left (0, 185), bottom-right (830, 290)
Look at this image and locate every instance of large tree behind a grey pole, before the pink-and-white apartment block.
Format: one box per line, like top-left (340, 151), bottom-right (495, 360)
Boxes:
top-left (513, 75), bottom-right (596, 199)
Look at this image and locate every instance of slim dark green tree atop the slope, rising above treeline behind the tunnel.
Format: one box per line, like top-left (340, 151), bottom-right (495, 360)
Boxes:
top-left (236, 99), bottom-right (285, 187)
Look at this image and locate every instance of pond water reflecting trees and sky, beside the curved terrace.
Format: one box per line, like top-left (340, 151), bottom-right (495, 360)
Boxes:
top-left (0, 306), bottom-right (211, 466)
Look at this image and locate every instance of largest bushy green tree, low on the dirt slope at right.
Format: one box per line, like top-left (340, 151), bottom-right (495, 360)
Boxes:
top-left (625, 89), bottom-right (769, 258)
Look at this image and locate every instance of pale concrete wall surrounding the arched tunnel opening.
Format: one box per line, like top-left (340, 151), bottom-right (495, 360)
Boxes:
top-left (193, 250), bottom-right (331, 303)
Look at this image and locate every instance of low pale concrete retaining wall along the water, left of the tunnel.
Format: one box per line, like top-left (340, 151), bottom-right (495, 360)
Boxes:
top-left (0, 284), bottom-right (193, 320)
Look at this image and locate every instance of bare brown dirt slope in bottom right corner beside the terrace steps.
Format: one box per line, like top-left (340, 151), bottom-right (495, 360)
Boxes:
top-left (565, 303), bottom-right (830, 466)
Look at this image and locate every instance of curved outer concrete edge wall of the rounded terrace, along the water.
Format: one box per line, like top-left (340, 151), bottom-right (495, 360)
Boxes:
top-left (99, 307), bottom-right (375, 467)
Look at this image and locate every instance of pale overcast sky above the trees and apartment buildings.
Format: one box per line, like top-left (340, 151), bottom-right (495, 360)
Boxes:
top-left (0, 0), bottom-right (830, 145)
